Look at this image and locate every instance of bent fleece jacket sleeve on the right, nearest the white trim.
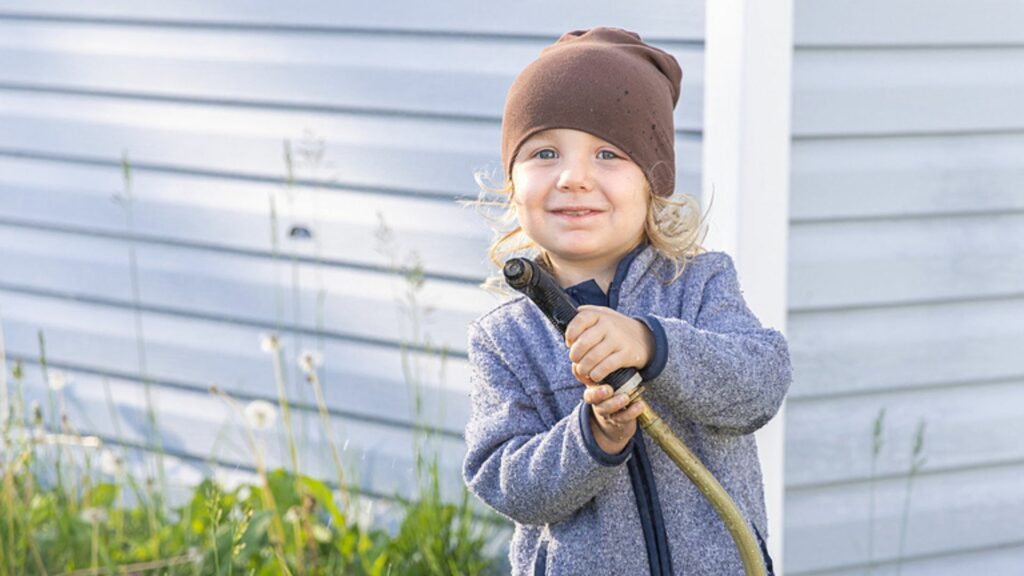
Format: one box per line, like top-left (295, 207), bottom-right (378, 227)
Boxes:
top-left (641, 253), bottom-right (793, 435)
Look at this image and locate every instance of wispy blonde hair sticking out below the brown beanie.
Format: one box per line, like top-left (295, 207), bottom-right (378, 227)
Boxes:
top-left (462, 166), bottom-right (711, 292)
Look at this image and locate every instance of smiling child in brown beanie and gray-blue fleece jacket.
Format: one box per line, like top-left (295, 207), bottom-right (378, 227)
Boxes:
top-left (463, 28), bottom-right (791, 576)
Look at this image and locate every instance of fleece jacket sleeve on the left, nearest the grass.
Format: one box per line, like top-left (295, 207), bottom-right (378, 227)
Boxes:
top-left (463, 323), bottom-right (632, 525)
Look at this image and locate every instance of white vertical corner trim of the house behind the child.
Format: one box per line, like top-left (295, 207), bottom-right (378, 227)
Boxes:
top-left (701, 0), bottom-right (793, 574)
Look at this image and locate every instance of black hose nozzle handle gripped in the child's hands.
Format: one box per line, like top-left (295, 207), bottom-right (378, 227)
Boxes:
top-left (502, 258), bottom-right (637, 390)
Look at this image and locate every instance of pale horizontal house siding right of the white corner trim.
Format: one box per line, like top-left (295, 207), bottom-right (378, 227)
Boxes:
top-left (785, 1), bottom-right (1024, 576)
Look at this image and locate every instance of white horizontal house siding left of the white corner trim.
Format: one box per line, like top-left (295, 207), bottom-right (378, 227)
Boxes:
top-left (0, 0), bottom-right (703, 528)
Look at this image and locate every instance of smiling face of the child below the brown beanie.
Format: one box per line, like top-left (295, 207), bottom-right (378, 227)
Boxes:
top-left (512, 128), bottom-right (649, 263)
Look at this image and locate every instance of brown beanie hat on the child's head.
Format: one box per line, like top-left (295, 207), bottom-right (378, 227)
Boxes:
top-left (502, 27), bottom-right (683, 197)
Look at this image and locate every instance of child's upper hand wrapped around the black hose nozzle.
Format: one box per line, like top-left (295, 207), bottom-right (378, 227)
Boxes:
top-left (565, 305), bottom-right (654, 385)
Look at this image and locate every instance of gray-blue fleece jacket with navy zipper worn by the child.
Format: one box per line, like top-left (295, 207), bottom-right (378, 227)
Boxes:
top-left (463, 246), bottom-right (792, 576)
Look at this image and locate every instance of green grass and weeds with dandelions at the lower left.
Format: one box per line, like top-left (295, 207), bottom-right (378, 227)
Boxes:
top-left (0, 330), bottom-right (497, 575)
